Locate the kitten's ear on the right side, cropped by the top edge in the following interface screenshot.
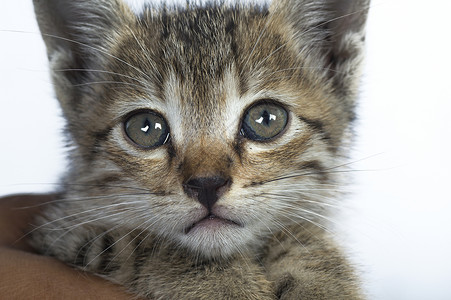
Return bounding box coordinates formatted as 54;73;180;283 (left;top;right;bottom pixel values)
271;0;370;88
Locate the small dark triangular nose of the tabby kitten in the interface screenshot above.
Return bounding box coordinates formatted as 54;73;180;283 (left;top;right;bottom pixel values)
183;176;231;210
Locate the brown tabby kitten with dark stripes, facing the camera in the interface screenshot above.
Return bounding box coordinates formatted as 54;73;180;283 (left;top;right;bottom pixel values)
32;0;369;299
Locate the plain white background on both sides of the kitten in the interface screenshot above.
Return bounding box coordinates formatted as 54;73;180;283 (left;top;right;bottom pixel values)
0;0;451;300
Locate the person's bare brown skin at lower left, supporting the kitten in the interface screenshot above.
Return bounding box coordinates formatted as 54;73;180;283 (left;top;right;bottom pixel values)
0;194;136;300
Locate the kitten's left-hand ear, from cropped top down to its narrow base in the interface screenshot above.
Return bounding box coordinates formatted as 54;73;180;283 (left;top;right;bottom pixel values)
33;0;133;117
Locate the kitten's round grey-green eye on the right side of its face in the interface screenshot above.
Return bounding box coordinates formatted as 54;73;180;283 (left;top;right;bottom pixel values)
241;103;288;141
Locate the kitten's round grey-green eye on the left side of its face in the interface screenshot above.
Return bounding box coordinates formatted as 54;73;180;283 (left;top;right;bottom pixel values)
124;111;169;148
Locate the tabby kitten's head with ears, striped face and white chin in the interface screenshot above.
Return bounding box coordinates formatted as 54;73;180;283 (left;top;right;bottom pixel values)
34;0;369;257
